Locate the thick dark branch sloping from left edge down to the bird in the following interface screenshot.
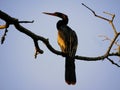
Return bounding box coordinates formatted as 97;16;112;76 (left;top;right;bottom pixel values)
0;11;65;56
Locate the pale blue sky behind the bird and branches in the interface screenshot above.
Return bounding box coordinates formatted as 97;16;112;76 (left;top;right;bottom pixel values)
0;0;120;90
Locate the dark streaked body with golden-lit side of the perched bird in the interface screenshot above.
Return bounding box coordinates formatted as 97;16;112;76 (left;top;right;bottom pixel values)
58;26;78;57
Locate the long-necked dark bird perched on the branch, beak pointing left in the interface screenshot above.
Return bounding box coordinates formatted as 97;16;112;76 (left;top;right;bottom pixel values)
44;12;78;85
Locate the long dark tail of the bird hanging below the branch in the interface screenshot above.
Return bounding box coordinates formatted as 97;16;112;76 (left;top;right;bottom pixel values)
65;57;76;85
